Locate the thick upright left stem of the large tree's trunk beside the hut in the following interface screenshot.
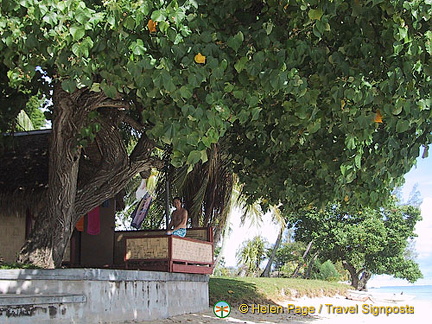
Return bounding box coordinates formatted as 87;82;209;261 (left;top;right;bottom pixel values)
18;86;87;268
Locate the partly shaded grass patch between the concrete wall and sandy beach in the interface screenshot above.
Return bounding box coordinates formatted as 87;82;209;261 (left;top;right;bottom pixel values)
209;277;350;305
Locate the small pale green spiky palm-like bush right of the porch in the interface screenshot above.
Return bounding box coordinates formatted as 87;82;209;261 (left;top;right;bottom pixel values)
236;236;267;276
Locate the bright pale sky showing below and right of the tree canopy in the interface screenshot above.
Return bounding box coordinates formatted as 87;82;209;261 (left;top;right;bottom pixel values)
222;153;432;287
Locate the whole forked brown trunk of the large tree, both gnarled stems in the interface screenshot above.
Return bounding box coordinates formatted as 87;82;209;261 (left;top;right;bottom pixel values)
18;86;160;268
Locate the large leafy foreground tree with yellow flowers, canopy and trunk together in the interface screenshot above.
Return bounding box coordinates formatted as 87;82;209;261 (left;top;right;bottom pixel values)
0;0;432;267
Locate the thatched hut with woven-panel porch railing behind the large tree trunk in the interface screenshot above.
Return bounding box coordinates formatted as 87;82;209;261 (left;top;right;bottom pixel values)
0;130;213;274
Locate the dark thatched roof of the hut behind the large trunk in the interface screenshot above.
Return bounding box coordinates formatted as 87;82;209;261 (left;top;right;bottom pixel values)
0;129;122;215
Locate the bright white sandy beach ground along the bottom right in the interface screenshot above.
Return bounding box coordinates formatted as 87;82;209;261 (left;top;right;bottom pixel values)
135;296;432;324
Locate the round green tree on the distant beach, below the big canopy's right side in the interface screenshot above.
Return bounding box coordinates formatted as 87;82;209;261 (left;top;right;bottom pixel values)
295;204;422;290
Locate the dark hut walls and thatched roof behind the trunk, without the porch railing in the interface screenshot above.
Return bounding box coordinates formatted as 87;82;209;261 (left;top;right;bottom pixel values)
0;130;123;267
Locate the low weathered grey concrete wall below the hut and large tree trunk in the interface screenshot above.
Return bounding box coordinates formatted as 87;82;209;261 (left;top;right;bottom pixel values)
0;269;209;324
